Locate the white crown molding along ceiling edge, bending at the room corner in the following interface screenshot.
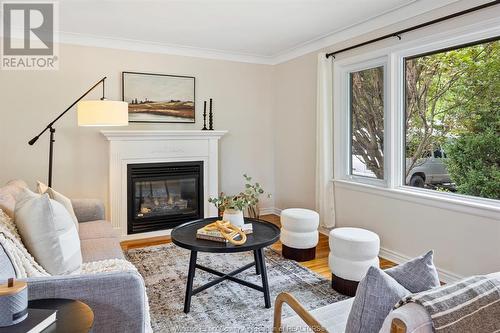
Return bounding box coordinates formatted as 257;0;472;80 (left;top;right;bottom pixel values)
52;0;466;65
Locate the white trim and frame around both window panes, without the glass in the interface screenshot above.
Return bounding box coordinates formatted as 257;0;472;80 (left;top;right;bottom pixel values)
333;18;500;217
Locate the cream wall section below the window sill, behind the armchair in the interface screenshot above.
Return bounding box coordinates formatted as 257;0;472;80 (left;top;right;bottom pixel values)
336;187;500;279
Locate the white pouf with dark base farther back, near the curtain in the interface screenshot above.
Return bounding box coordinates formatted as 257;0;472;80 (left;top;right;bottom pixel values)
280;208;319;261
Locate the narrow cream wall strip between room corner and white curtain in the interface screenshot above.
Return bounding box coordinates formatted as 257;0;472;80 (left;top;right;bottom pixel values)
274;54;317;209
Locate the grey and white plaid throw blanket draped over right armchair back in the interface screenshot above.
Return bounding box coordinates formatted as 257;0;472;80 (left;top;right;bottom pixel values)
396;276;500;333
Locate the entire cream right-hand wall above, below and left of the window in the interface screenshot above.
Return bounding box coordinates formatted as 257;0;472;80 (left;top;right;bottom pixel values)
274;1;500;279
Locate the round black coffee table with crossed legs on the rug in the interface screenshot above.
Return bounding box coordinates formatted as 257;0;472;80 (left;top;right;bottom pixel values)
171;217;280;313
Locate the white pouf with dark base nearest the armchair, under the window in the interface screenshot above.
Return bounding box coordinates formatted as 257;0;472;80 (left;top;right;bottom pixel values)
328;228;380;296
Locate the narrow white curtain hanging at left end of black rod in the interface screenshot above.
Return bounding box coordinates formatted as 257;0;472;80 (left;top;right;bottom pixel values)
316;53;335;228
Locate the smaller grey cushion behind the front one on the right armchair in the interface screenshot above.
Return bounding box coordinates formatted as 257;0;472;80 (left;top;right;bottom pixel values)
385;250;441;293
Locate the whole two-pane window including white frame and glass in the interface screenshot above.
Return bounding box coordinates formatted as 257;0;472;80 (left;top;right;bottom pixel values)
332;24;500;211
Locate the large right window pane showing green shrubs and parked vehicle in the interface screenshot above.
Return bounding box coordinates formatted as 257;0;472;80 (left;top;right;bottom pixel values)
403;40;500;200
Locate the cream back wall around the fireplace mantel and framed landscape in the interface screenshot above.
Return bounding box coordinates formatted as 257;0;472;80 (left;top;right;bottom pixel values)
0;45;274;207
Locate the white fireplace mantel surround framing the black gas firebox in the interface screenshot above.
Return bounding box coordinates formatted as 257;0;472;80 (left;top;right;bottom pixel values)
101;130;227;240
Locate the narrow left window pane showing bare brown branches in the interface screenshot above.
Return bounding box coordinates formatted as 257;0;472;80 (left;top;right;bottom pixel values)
349;66;384;179
